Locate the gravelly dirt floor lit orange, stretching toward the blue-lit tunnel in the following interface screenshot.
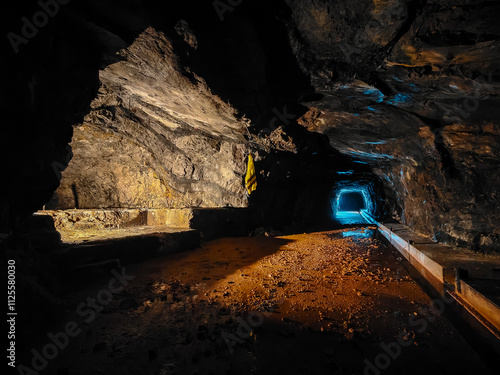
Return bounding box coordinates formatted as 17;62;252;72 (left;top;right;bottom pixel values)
27;227;489;375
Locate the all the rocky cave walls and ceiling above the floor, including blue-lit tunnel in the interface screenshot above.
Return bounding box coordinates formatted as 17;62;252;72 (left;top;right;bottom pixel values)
0;0;500;374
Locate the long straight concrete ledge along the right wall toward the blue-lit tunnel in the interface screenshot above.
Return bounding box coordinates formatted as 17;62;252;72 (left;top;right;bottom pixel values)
368;216;500;353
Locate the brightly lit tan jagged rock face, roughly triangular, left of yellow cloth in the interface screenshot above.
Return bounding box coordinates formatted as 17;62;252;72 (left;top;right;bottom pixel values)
50;28;248;209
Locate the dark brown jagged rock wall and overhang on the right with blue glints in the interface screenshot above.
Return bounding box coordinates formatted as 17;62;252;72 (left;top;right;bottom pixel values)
288;0;500;250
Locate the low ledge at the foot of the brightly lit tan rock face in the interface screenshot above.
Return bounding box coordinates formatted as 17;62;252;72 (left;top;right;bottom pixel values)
34;207;249;279
